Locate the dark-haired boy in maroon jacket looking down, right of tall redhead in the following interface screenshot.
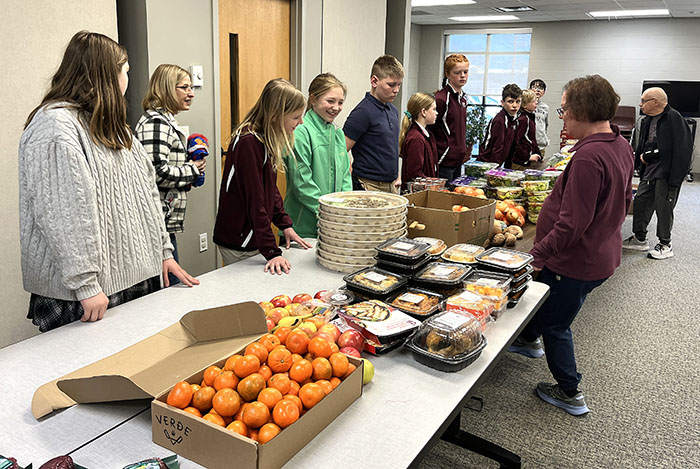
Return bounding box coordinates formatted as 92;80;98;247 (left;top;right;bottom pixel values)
476;83;523;165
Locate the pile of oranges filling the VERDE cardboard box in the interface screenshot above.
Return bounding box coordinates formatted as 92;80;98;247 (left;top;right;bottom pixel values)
166;327;355;444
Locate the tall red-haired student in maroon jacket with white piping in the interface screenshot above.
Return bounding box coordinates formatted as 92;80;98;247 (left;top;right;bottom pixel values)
428;54;469;182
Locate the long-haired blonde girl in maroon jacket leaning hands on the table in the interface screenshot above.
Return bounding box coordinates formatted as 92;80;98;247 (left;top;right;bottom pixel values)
214;78;311;274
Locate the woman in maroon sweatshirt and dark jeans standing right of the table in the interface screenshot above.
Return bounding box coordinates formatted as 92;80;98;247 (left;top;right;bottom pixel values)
509;75;634;415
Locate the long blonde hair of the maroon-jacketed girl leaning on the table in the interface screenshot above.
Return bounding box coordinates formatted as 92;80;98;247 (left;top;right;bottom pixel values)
232;78;306;170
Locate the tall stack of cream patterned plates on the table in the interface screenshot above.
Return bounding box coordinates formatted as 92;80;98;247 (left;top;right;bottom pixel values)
316;191;408;272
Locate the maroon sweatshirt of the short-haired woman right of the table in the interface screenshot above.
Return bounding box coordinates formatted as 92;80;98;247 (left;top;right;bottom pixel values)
530;126;634;281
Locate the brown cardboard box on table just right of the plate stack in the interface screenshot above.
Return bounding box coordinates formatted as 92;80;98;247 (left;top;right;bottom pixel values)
405;191;496;247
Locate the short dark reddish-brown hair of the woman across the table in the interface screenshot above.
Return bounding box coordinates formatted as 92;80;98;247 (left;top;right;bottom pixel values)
564;75;620;122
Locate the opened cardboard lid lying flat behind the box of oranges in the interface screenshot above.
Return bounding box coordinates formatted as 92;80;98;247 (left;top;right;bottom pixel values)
32;301;267;419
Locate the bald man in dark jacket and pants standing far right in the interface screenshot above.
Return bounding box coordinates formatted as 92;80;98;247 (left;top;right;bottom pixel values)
622;88;693;259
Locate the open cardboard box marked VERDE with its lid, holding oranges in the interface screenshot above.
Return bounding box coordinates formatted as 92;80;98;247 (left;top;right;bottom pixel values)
32;302;363;468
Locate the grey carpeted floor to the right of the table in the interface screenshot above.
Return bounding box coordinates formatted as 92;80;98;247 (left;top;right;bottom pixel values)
420;177;700;469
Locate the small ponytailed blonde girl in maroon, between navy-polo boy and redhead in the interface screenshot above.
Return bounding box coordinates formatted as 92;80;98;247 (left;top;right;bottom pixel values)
399;93;438;190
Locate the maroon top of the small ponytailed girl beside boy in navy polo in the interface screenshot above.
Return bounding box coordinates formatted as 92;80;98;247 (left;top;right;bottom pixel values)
401;122;438;189
